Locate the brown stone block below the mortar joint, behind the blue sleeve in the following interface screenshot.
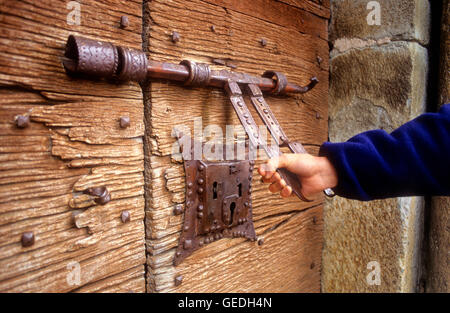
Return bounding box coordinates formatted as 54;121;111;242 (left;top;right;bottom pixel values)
322;42;428;292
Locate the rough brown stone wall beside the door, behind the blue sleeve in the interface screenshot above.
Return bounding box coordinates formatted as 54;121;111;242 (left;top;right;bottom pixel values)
322;0;430;292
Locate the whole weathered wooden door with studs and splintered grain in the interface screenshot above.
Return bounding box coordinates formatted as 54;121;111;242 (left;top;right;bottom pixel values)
0;0;329;292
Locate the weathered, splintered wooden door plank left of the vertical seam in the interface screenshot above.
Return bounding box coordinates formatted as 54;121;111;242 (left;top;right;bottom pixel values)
0;0;145;292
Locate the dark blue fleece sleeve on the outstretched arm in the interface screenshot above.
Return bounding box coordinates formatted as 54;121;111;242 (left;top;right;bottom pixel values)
319;104;450;201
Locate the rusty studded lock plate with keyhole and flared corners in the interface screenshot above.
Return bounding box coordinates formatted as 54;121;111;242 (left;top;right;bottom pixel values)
173;136;256;265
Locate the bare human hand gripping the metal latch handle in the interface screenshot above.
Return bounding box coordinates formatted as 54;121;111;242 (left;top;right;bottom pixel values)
258;153;338;198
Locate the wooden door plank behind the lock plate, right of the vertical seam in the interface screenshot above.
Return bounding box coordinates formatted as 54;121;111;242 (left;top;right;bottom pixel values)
144;0;328;292
